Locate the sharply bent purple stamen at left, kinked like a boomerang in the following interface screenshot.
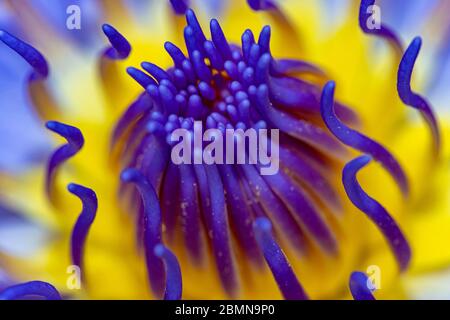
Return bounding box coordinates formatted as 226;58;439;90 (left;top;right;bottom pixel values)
46;121;84;199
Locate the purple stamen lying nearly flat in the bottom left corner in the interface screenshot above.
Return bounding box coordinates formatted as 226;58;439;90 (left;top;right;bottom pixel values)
0;281;61;300
